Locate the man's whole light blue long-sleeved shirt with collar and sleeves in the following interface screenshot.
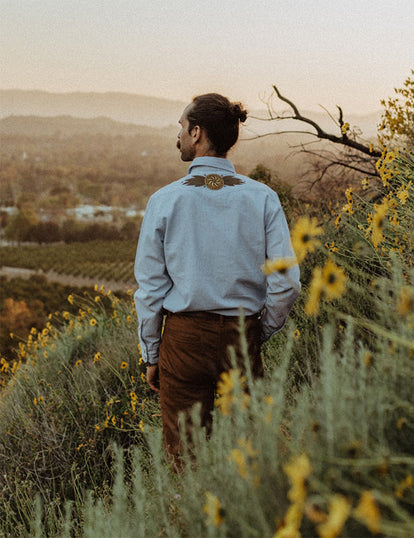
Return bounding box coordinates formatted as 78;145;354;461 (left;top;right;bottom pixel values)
135;157;300;364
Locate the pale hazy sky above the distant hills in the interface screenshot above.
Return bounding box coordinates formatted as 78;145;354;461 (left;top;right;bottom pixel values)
0;0;414;112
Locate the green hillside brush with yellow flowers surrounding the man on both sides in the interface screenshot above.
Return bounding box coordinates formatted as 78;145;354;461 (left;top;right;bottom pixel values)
0;77;414;538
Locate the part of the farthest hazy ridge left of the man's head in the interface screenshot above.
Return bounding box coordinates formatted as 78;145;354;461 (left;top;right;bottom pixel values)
0;90;186;127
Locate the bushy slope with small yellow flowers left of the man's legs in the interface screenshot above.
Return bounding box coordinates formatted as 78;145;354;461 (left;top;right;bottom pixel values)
0;289;158;536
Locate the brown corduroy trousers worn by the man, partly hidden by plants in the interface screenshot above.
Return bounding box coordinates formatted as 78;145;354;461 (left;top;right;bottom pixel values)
159;312;263;462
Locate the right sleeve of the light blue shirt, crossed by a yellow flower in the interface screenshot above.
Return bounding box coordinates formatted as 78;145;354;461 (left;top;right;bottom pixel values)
262;192;301;342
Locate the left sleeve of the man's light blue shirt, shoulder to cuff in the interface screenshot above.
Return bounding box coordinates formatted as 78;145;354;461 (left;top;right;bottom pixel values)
134;198;172;364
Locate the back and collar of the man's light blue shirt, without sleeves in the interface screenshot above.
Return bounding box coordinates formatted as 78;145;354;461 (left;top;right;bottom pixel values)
144;157;276;315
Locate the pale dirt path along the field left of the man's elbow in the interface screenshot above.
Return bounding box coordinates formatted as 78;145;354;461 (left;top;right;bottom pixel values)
0;266;137;291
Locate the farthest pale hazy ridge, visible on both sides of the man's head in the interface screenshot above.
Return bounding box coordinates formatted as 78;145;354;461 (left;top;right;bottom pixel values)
0;90;380;137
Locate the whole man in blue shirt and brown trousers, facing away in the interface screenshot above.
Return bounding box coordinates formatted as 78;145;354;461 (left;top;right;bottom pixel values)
135;93;300;459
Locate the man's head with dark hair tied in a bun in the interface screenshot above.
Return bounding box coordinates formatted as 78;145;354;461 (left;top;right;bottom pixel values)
177;93;247;161
